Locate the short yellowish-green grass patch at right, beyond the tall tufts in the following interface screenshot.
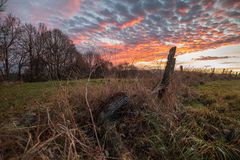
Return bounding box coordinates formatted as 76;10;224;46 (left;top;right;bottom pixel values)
192;80;240;120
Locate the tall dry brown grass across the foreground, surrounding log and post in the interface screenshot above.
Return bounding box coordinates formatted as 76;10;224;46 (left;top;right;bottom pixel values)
0;73;240;160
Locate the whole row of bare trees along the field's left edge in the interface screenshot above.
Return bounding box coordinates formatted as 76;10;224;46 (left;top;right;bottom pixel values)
0;15;112;81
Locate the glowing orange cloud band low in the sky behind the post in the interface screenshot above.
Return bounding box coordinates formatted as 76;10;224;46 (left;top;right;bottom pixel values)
102;31;240;64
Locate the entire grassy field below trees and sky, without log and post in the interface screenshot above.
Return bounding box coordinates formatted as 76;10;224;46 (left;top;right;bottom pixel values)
0;79;240;160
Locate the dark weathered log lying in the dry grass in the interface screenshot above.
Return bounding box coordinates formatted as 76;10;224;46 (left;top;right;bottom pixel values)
96;92;129;123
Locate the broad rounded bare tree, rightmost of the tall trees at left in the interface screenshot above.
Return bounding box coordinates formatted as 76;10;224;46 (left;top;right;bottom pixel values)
44;29;77;79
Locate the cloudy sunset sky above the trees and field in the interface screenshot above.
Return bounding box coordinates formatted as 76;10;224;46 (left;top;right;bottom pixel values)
1;0;240;71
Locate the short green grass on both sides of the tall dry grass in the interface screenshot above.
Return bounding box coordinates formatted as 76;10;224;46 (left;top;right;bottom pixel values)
0;79;240;113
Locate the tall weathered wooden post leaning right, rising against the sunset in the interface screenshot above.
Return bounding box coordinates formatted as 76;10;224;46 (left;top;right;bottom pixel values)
154;47;176;99
